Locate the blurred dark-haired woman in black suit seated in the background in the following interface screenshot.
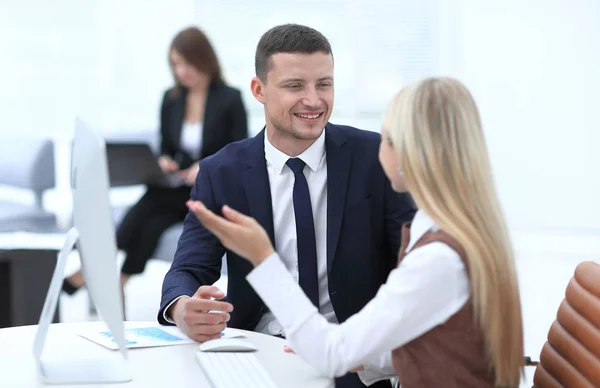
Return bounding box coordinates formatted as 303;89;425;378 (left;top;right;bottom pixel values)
63;27;248;294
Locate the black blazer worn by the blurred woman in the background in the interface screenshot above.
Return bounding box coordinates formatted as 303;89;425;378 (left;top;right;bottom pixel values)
160;83;248;169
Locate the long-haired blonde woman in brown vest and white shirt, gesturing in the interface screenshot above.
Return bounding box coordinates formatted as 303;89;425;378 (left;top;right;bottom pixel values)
188;78;523;388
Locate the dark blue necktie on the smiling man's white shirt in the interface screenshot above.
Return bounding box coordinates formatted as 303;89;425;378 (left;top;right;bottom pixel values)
286;158;319;308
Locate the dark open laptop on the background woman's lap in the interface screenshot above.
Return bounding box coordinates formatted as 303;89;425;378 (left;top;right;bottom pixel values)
106;142;186;188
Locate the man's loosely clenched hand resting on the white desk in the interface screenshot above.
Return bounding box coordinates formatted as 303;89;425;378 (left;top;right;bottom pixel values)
170;286;233;342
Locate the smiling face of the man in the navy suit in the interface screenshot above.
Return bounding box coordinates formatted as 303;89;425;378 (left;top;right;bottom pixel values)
252;52;333;141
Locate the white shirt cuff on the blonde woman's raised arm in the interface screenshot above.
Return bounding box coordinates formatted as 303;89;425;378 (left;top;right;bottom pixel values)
246;252;317;333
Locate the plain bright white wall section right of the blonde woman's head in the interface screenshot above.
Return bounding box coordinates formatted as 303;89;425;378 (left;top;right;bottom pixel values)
454;0;600;238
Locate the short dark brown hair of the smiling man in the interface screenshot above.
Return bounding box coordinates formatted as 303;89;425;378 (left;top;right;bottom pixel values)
254;24;331;83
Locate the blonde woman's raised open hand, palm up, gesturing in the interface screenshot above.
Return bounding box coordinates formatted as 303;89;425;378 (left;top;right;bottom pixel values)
186;201;274;266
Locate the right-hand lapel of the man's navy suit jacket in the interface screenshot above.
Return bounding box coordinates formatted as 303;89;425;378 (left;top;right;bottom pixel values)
325;124;352;274
